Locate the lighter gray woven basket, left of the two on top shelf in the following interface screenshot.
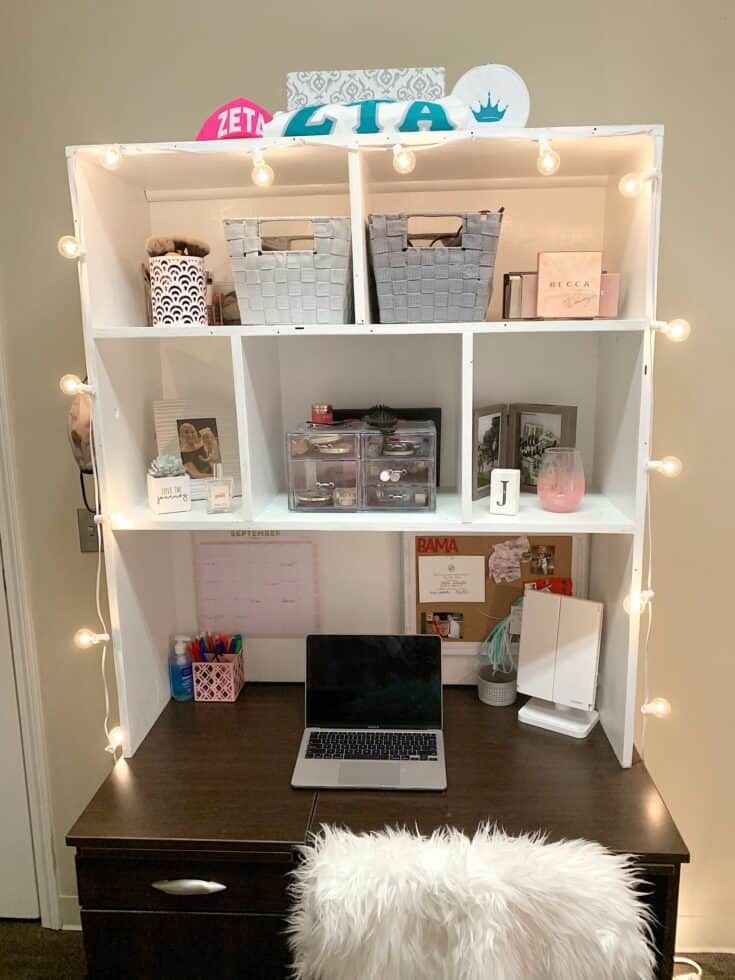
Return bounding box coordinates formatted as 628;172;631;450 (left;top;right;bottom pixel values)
224;217;352;325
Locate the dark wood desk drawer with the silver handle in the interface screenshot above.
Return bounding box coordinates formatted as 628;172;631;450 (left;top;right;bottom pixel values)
77;851;294;915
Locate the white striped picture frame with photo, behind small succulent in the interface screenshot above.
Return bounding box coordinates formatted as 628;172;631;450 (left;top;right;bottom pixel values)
153;398;242;500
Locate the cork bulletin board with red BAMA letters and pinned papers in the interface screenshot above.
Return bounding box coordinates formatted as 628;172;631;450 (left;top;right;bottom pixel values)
404;534;586;652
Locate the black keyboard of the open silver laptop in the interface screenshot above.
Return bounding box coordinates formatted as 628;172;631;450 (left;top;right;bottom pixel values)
306;732;437;762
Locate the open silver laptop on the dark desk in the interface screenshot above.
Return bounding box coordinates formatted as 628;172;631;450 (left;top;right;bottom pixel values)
291;634;447;790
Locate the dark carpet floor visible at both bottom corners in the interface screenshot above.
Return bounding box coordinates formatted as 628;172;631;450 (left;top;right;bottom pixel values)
0;919;735;980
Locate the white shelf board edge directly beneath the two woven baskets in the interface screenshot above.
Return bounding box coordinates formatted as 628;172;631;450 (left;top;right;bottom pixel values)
91;319;650;342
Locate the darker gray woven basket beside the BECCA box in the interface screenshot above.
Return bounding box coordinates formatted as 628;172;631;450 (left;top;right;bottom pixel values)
368;210;503;323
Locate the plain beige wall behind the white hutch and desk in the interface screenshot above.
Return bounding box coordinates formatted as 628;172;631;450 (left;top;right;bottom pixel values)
0;0;735;948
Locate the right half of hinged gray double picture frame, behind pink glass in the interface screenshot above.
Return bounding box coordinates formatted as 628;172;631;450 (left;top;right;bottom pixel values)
509;404;577;493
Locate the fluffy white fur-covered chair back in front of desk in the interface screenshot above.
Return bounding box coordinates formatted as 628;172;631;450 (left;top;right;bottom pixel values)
289;827;654;980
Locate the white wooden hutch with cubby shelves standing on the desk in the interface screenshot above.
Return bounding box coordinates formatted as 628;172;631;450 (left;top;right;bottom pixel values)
67;126;663;766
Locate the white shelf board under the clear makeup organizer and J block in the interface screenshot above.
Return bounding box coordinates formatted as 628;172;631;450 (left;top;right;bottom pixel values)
113;491;636;534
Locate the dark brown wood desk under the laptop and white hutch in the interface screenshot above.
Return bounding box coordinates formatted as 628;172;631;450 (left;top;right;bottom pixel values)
67;684;689;980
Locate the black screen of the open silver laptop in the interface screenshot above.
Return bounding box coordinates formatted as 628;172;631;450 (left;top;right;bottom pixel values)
306;634;442;729
